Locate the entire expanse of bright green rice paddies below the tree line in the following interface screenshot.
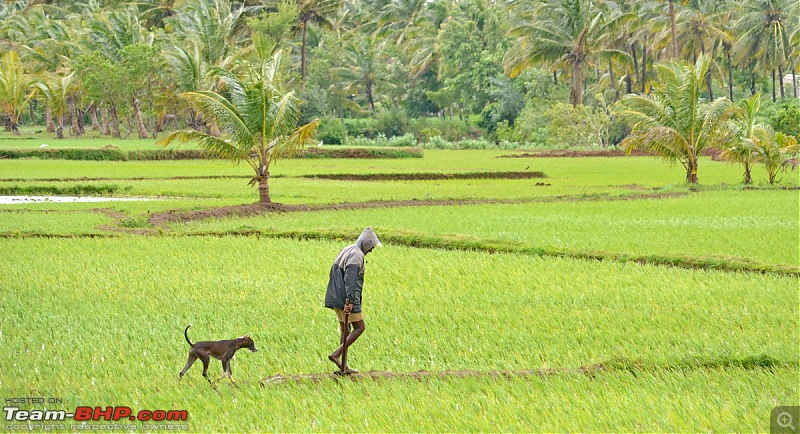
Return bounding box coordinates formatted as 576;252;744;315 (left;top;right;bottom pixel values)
0;137;800;432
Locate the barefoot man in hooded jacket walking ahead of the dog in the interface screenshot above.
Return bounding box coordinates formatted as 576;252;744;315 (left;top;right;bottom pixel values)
325;228;381;374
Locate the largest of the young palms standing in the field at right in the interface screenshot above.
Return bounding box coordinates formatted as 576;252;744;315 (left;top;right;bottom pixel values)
617;55;732;184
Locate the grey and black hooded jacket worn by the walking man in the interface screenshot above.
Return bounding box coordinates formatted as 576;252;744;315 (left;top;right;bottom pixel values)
325;228;381;313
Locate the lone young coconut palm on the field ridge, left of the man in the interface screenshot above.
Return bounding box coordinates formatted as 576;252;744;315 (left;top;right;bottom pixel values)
157;51;317;205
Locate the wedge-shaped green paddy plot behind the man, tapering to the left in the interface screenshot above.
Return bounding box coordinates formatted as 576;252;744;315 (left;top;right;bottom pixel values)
171;191;800;267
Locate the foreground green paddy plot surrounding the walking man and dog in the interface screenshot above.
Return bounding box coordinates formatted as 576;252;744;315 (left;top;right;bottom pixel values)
0;237;799;431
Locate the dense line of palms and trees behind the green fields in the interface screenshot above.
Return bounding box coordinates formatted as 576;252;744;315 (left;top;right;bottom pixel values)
0;0;800;145
